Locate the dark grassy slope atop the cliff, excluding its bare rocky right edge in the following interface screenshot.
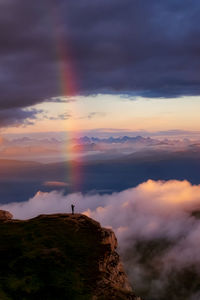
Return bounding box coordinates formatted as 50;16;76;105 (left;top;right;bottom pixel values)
0;215;108;300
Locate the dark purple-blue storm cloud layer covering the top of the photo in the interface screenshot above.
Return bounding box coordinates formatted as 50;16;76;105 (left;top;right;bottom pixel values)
0;0;200;122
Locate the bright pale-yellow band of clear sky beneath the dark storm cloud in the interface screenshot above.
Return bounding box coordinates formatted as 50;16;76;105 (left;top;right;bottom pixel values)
3;94;200;134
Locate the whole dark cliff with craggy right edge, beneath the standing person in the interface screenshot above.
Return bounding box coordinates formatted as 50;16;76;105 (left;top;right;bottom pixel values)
0;213;140;300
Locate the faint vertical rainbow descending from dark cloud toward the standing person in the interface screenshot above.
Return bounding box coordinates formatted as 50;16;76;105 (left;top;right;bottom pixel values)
48;1;81;191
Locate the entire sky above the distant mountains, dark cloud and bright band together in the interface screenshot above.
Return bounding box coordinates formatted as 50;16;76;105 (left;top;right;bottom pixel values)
0;0;200;134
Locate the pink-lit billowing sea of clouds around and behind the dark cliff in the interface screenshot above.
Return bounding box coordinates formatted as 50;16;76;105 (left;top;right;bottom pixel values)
0;180;200;300
